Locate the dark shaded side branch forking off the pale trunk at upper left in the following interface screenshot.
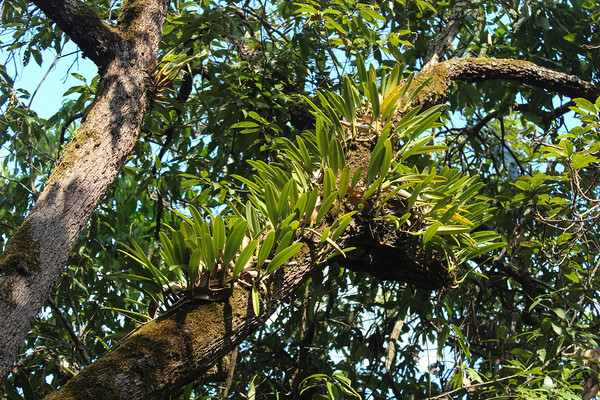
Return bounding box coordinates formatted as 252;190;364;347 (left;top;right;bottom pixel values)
32;0;121;69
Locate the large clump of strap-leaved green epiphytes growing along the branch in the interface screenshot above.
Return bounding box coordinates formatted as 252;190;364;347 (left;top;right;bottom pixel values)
112;57;503;315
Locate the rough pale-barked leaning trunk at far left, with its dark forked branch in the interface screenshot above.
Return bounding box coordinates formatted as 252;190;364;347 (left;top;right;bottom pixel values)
0;0;168;387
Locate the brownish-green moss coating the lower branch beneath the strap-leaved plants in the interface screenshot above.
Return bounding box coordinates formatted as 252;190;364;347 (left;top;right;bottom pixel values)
46;289;249;400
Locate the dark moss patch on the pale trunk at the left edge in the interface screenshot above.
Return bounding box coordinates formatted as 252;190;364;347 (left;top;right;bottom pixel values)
0;222;40;276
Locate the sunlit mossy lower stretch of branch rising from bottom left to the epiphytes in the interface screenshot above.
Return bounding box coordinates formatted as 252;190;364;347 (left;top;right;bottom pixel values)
47;248;316;400
